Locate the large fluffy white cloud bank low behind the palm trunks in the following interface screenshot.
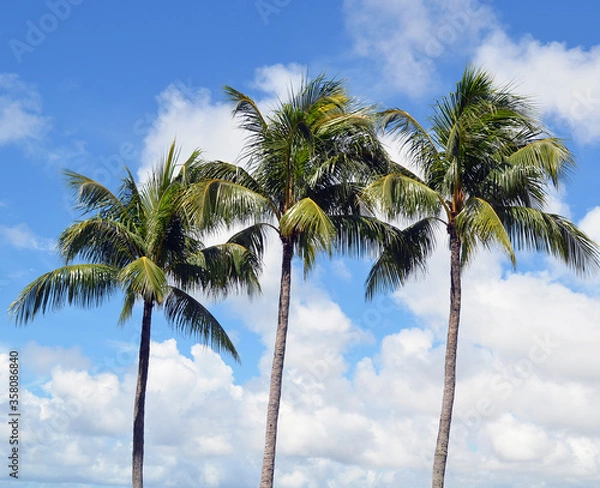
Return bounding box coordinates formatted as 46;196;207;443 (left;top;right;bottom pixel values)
7;241;600;488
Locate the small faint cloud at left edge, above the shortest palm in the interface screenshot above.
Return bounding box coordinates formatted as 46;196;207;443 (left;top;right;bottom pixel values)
0;73;49;146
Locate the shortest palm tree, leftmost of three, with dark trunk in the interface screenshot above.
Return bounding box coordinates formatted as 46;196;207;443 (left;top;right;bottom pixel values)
9;144;262;488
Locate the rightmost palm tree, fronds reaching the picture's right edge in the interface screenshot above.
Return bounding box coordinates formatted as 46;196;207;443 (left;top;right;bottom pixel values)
365;67;599;488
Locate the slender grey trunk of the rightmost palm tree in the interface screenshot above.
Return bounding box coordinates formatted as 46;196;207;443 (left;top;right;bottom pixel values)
432;223;461;488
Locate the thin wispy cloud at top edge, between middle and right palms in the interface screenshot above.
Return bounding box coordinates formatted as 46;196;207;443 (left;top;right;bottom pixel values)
344;0;496;96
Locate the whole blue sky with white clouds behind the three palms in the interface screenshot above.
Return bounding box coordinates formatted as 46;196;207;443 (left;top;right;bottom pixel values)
0;0;600;488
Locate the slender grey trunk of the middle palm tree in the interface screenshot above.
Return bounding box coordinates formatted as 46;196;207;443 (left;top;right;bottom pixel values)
260;238;294;488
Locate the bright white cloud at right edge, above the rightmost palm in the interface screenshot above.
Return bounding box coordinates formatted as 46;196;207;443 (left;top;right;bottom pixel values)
476;31;600;143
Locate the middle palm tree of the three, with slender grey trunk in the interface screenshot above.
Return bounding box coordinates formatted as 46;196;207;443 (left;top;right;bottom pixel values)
190;76;412;488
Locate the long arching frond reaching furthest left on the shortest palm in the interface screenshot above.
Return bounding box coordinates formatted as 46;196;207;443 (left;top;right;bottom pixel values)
8;264;119;324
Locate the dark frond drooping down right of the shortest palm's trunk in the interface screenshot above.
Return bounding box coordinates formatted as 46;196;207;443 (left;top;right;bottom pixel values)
163;287;240;362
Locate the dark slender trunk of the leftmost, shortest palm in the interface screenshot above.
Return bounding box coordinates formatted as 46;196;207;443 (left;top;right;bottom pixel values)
131;301;154;488
